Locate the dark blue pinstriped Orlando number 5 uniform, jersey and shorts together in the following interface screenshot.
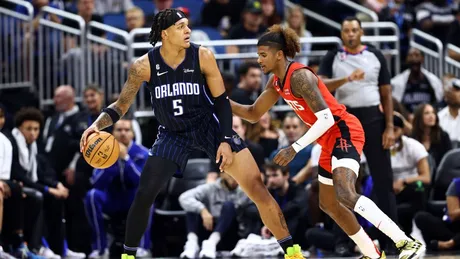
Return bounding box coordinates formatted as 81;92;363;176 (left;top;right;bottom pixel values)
148;44;246;177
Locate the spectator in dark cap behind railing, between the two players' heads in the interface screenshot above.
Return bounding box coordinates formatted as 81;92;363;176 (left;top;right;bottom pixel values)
227;0;266;53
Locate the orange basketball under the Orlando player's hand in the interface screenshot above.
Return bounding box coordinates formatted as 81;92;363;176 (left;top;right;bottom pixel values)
83;131;120;169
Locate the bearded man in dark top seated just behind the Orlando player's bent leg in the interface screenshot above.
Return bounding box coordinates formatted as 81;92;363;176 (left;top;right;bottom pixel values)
261;165;307;244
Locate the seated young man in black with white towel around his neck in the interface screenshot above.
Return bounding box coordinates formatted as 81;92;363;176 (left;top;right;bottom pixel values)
10;108;86;258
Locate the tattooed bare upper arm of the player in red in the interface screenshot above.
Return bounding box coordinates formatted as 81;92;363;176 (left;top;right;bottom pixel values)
291;69;328;113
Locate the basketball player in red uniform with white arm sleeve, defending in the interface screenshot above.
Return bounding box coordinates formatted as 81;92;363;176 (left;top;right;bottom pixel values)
230;25;425;259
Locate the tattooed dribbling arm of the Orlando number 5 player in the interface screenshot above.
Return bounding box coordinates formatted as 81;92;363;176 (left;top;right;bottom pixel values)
95;59;150;130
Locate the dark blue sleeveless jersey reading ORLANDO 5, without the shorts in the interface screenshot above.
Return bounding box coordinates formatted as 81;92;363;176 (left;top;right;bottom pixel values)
147;43;214;132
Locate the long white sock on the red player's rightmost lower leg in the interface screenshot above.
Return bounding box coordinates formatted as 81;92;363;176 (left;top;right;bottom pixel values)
354;195;410;243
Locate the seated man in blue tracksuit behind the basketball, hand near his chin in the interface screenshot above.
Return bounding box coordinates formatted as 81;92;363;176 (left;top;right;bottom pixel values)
85;119;150;259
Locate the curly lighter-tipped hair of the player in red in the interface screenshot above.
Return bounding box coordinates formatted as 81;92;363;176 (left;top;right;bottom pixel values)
257;24;300;58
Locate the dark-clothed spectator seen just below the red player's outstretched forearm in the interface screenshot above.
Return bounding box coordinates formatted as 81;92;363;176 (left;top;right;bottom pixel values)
246;112;282;159
